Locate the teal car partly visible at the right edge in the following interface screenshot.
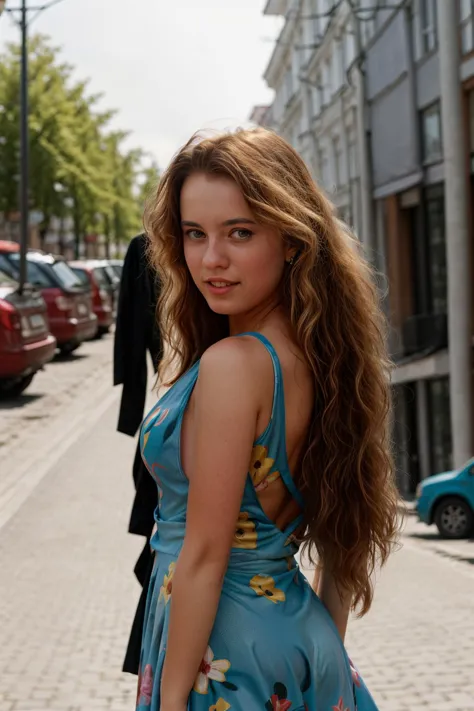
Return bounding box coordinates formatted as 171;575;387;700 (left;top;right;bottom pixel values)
416;458;474;538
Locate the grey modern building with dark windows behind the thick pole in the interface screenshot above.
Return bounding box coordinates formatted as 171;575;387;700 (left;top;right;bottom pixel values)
366;0;474;494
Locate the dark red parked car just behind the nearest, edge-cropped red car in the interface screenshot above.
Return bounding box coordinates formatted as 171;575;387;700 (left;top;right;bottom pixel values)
0;242;97;355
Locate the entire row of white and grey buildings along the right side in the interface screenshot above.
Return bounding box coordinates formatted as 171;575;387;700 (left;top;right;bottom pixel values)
258;0;474;495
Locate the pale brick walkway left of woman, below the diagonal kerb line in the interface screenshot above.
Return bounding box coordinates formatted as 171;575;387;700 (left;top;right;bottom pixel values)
0;390;143;711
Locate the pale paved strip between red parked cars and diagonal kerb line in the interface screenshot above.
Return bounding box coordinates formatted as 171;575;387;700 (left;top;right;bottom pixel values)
0;335;116;528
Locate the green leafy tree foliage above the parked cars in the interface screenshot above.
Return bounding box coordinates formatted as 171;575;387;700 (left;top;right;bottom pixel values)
0;35;158;254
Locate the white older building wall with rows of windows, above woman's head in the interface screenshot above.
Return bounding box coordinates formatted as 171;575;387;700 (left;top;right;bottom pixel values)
265;0;372;232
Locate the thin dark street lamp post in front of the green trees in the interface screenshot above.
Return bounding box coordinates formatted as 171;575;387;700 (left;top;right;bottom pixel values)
0;0;67;292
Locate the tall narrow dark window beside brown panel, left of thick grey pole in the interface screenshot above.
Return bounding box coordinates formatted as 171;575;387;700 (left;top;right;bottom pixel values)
426;186;448;314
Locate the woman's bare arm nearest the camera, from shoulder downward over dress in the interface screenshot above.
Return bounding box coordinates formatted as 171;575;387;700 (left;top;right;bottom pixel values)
160;339;259;711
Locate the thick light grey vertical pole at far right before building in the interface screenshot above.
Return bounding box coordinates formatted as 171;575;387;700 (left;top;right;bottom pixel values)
437;0;474;467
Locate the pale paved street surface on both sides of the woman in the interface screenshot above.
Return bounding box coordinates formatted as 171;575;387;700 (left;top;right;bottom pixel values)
0;337;474;711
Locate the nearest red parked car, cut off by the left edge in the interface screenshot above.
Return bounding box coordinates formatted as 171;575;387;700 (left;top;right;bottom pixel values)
0;269;56;397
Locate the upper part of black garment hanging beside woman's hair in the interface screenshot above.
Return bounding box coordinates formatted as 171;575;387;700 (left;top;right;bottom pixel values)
114;234;161;437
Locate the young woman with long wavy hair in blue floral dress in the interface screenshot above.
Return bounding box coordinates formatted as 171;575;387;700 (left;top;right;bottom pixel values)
137;129;397;711
